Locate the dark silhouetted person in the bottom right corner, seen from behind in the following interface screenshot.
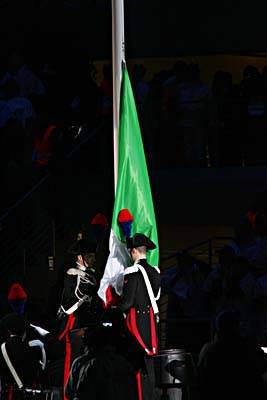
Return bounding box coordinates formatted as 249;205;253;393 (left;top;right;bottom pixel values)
198;310;267;400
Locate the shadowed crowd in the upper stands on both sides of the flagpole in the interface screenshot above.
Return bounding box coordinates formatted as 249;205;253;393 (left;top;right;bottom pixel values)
0;50;267;188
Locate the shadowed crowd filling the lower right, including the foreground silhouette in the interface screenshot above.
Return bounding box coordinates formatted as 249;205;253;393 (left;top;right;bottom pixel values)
162;193;267;399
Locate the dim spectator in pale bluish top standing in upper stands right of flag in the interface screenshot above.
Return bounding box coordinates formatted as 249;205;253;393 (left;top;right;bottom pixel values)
163;62;210;166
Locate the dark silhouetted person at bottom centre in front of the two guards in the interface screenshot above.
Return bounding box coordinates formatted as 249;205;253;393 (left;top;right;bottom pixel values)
73;325;138;400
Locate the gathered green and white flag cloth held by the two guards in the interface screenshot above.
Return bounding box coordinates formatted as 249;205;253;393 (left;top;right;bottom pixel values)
98;67;159;302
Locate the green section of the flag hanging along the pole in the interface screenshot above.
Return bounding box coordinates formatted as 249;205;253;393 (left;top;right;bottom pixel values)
112;68;159;265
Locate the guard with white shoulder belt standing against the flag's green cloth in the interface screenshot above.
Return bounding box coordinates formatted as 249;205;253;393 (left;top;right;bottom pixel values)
118;233;160;400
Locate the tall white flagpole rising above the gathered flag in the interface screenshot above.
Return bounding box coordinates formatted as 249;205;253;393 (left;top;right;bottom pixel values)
111;0;125;193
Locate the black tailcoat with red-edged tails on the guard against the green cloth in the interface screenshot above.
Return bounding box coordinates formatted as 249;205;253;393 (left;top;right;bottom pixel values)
118;259;160;354
